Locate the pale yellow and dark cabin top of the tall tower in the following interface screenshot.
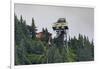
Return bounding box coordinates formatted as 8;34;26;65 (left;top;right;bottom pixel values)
52;18;68;30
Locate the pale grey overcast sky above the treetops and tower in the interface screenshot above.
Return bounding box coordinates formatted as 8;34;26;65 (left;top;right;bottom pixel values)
14;4;94;40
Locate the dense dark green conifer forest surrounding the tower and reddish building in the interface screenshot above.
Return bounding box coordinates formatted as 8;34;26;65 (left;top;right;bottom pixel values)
14;15;94;65
